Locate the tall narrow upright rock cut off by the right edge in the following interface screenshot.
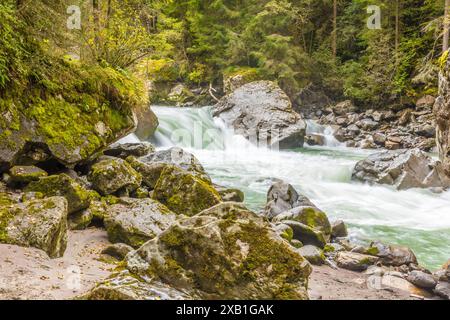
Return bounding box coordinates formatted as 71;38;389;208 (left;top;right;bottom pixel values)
434;52;450;176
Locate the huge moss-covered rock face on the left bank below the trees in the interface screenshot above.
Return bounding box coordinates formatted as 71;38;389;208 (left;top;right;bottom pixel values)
0;50;151;170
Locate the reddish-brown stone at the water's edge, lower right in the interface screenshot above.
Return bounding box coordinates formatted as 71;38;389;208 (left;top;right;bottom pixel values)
368;241;417;267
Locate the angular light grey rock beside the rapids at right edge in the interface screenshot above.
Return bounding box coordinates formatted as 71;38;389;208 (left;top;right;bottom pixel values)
352;149;450;190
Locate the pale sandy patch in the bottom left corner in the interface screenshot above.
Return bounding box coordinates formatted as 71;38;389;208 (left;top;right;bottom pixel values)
0;228;115;300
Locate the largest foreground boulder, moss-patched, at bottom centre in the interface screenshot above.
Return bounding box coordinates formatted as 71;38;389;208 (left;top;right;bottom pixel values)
126;203;311;299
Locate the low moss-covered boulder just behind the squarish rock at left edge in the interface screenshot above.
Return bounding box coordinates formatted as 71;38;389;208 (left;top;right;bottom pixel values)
25;173;91;214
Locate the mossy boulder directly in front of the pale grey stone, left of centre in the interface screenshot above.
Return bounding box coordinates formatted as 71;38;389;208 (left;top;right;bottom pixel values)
152;166;221;216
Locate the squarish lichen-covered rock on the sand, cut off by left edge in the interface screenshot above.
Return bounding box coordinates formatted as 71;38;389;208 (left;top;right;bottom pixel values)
0;197;67;258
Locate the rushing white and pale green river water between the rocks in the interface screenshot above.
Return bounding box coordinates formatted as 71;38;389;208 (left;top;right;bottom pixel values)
135;107;450;269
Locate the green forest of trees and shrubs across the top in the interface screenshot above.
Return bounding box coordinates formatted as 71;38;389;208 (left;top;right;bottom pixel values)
0;0;449;107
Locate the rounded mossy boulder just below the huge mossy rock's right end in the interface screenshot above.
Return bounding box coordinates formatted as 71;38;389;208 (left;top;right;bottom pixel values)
88;158;142;195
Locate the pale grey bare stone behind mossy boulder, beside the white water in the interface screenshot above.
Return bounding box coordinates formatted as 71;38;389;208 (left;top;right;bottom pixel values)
138;147;211;182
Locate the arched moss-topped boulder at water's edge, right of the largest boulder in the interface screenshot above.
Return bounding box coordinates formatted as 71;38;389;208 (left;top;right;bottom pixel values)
273;206;331;242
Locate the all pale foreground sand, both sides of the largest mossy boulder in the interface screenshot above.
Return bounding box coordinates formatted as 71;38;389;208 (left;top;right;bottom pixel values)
0;228;436;300
